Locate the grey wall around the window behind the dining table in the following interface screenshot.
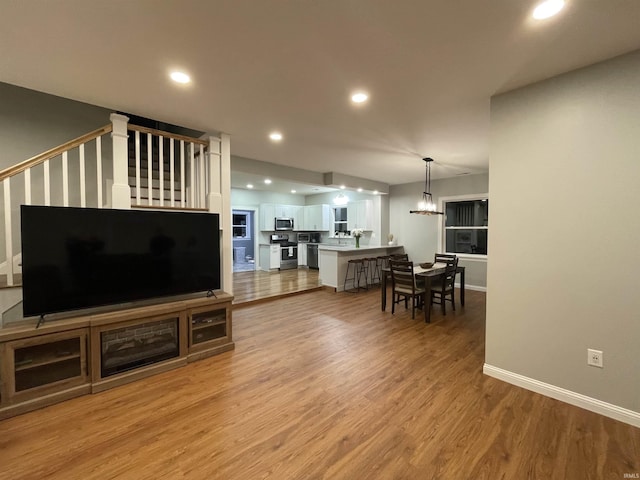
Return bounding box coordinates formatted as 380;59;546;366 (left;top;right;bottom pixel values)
389;174;492;289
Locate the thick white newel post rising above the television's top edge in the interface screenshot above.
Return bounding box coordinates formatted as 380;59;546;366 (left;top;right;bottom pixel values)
109;113;131;210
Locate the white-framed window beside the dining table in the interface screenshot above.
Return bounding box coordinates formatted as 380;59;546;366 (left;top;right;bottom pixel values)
443;198;489;255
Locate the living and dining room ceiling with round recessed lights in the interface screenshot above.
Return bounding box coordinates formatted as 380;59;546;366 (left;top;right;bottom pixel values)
0;0;640;192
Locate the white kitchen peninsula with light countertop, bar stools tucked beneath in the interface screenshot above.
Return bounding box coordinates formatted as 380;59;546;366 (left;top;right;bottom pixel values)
318;244;404;292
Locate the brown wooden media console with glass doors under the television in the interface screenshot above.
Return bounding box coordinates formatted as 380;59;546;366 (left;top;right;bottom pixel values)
0;293;234;420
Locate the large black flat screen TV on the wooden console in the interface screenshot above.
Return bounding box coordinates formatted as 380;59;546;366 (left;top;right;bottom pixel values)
21;205;220;317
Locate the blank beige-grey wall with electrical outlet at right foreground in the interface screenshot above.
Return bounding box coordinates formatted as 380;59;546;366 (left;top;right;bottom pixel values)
485;51;640;425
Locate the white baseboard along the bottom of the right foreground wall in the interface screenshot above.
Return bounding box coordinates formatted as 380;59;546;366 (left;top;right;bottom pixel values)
482;363;640;428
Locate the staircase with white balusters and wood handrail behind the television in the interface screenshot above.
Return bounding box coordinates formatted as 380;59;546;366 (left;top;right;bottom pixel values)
0;114;231;287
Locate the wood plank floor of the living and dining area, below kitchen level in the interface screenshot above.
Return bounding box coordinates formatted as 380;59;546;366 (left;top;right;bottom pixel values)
0;289;640;480
